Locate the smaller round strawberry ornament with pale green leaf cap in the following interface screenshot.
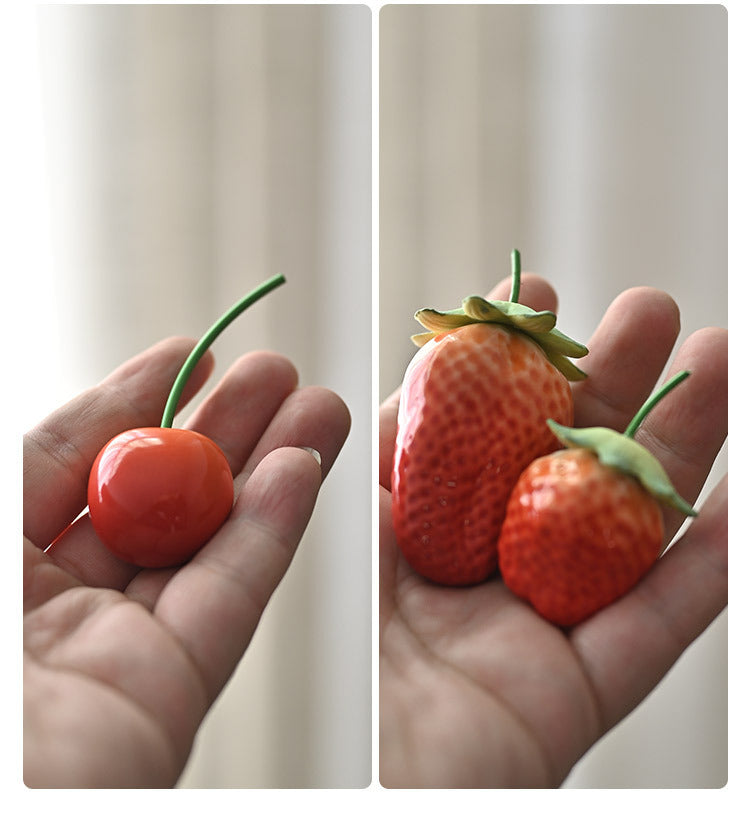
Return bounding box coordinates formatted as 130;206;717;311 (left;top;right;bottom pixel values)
498;372;696;627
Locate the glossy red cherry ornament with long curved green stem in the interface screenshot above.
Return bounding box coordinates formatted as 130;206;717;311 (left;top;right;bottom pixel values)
88;275;284;568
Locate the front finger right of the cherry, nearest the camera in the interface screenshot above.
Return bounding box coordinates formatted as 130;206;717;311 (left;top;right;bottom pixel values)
154;448;321;699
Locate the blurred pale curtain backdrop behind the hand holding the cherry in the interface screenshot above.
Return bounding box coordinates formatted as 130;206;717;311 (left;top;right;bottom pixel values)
31;5;372;788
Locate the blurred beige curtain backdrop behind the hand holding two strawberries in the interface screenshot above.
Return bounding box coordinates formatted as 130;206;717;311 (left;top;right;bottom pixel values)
379;4;727;788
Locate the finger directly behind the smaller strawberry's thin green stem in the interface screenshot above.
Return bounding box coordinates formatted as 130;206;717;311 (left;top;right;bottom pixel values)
635;327;728;541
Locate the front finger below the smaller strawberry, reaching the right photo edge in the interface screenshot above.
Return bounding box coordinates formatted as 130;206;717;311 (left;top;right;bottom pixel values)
571;477;727;731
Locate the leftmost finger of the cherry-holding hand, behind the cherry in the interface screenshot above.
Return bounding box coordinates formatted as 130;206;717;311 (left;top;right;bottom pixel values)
23;338;213;549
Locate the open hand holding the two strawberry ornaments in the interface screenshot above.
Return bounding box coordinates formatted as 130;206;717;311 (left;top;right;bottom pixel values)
380;275;727;788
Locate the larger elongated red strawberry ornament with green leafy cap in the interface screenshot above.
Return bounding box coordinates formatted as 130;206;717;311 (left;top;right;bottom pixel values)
392;251;587;585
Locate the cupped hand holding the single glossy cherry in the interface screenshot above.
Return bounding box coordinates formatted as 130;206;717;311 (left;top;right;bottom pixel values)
24;338;349;788
